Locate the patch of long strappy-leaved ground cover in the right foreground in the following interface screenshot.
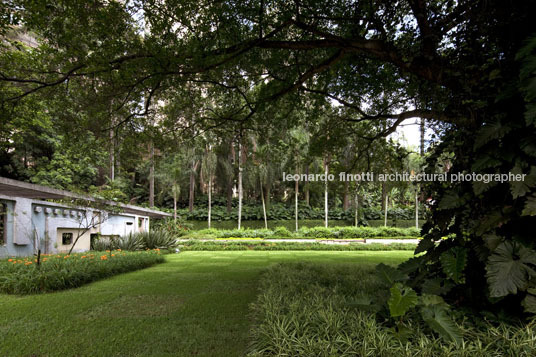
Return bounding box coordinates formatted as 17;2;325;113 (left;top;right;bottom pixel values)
250;263;536;356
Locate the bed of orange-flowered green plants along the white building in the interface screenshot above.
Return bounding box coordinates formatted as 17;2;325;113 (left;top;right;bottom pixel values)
0;249;164;294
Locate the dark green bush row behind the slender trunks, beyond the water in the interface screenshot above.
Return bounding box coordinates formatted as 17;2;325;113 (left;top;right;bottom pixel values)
179;203;424;224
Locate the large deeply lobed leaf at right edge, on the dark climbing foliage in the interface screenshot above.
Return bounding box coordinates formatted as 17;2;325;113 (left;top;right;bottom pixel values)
486;241;536;297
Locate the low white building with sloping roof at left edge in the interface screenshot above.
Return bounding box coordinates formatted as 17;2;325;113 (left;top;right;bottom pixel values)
0;177;171;258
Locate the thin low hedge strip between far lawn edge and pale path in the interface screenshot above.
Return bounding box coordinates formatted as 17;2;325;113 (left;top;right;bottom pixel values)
180;240;417;251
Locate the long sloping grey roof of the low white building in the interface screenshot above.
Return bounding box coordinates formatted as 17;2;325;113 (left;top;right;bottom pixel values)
0;177;171;218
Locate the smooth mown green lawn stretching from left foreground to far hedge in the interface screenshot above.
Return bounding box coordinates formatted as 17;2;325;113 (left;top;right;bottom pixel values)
0;251;413;356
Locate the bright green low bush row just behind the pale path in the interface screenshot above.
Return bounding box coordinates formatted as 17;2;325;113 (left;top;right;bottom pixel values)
185;226;420;239
